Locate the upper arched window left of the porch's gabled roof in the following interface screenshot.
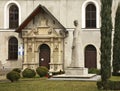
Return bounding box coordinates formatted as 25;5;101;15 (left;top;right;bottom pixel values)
9;5;19;29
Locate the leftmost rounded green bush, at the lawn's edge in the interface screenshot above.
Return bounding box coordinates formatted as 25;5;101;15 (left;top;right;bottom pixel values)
6;71;20;82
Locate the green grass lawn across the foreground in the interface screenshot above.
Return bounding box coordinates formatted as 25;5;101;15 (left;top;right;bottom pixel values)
0;77;120;91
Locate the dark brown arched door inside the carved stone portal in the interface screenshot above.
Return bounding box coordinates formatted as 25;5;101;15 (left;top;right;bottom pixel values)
39;44;50;69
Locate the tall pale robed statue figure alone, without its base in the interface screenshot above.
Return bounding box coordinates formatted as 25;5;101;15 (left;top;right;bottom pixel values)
70;20;80;67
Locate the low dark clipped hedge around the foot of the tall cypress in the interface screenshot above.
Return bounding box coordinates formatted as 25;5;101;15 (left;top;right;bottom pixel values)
97;81;120;90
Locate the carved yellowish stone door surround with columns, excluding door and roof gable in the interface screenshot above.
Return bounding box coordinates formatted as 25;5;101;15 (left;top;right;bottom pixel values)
23;27;63;71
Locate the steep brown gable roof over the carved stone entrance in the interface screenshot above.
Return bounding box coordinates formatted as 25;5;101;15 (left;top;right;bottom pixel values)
15;5;66;33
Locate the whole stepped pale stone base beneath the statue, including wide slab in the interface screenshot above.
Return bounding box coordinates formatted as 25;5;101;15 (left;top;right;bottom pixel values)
50;67;100;81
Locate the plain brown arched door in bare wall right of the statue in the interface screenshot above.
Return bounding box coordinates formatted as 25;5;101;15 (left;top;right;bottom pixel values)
85;45;97;68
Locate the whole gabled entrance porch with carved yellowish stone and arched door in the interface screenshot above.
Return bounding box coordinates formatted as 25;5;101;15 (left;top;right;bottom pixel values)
19;6;66;72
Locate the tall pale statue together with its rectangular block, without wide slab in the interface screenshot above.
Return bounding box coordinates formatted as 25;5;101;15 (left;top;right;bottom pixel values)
65;20;88;75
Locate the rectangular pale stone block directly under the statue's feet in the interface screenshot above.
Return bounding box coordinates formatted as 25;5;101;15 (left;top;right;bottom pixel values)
65;67;88;75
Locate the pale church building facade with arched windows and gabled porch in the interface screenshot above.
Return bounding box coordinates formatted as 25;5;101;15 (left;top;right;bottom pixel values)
0;0;120;71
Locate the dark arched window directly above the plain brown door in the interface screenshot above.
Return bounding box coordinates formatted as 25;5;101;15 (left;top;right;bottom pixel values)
86;4;96;28
